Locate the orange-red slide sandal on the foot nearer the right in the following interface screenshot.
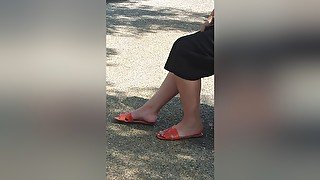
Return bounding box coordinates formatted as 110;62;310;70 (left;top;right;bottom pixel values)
156;127;203;141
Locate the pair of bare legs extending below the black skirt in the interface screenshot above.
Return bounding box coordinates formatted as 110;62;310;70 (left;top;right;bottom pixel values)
131;72;203;136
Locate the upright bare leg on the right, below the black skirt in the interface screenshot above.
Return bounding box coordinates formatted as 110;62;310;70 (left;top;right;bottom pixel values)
170;76;203;136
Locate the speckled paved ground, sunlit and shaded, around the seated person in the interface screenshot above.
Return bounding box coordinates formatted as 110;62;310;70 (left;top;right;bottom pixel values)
106;0;213;179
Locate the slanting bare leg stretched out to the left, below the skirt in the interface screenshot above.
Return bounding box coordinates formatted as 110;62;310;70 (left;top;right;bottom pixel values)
131;72;178;122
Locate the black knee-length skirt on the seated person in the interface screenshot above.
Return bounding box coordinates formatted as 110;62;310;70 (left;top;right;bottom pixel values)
164;26;214;80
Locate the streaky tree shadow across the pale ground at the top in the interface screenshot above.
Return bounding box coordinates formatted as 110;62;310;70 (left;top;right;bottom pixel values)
106;2;207;36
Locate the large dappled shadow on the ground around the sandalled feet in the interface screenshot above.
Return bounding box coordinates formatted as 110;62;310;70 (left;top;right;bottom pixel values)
106;88;214;179
